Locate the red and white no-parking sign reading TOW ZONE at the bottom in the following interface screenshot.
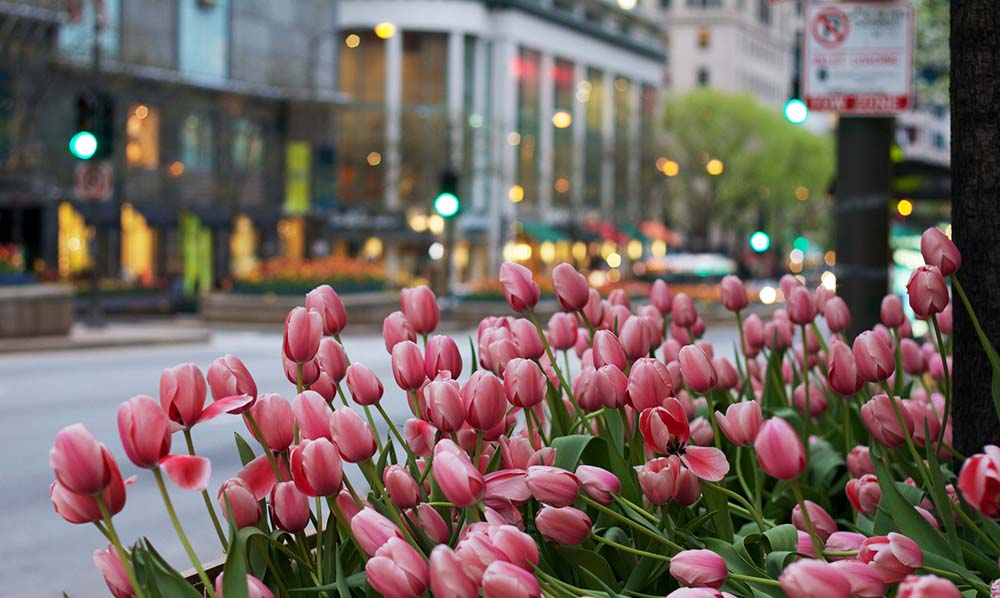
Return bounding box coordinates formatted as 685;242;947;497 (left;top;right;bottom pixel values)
802;0;913;115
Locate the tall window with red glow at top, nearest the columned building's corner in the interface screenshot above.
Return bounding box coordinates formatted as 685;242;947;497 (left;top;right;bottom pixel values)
513;48;542;202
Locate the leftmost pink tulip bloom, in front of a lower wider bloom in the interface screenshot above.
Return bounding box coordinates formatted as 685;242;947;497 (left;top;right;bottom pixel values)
49;424;112;496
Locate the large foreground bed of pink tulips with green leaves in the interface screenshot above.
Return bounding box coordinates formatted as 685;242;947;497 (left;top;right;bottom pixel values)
50;229;1000;598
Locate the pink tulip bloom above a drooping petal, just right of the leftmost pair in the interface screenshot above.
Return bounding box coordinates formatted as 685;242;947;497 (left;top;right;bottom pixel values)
118;395;171;469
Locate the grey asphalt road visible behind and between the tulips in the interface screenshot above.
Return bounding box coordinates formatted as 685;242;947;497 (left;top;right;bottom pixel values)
0;328;735;598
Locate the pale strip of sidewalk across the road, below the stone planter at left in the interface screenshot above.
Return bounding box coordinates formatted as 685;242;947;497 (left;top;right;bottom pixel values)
0;318;211;354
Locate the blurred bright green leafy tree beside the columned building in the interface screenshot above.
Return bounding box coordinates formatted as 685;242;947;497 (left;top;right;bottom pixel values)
665;89;834;250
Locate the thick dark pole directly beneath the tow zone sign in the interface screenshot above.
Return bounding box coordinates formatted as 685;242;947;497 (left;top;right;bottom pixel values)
835;116;895;338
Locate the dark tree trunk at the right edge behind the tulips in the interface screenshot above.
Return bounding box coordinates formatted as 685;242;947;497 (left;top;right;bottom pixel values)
951;0;1000;454
